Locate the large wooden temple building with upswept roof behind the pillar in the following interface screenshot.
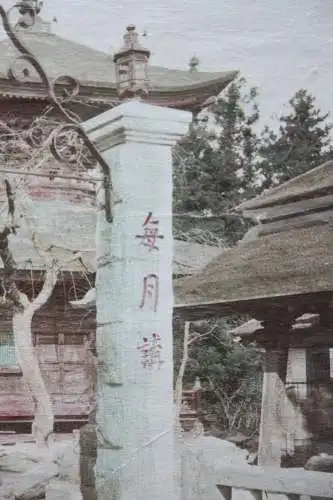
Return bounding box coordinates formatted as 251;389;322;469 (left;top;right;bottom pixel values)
0;5;237;432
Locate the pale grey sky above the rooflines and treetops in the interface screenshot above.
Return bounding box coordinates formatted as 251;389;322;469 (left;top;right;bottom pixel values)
3;0;333;125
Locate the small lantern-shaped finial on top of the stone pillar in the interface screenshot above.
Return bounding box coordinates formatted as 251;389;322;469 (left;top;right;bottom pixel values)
113;24;150;98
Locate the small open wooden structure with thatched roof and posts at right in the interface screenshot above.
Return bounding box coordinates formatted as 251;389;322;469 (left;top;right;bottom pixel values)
175;162;333;466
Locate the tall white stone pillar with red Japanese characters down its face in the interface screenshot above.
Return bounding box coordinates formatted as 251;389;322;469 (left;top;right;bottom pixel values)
84;101;191;500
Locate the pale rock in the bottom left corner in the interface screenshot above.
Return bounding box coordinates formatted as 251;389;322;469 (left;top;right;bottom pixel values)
0;463;58;500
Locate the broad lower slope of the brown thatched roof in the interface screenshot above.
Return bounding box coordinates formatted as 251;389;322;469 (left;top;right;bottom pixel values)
175;224;333;307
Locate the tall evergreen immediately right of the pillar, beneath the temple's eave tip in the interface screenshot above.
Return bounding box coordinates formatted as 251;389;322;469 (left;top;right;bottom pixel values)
174;79;259;243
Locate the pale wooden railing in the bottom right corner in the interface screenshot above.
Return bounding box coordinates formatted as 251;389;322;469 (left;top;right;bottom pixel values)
217;466;333;500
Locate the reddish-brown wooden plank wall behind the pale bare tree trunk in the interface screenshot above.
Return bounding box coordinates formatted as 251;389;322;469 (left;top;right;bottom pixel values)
0;283;95;421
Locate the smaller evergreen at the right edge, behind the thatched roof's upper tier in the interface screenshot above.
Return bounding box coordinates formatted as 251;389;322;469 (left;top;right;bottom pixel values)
257;89;332;189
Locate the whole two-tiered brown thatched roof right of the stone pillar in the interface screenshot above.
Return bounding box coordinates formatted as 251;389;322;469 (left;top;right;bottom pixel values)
175;161;333;317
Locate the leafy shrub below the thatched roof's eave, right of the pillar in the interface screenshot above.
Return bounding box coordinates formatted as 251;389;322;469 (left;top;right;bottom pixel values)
174;319;263;435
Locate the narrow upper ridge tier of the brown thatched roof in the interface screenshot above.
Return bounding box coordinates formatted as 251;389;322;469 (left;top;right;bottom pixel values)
237;161;333;212
